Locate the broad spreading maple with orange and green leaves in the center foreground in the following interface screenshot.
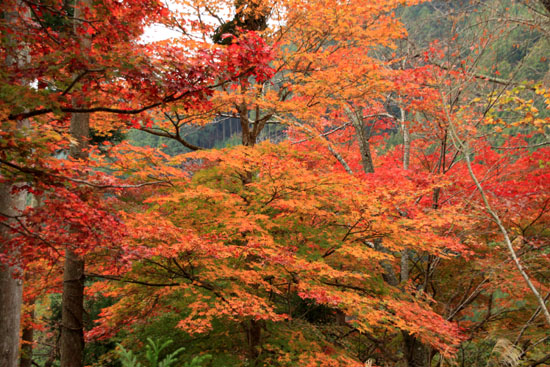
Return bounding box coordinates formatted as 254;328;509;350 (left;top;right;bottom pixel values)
83;144;466;364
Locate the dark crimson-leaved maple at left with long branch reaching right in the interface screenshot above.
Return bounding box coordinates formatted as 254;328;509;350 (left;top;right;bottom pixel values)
0;1;276;366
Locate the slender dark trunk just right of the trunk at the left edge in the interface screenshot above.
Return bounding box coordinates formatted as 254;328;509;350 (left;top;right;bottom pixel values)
60;0;92;367
